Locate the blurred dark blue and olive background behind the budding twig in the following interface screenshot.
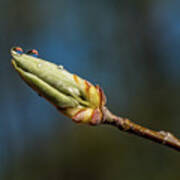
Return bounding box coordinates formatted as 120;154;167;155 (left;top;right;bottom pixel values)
0;0;180;180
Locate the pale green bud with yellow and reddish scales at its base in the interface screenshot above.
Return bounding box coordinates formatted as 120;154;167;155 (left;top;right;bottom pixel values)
11;47;106;125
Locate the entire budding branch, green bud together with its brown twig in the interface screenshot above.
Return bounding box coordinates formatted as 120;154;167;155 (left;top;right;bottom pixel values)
11;47;180;151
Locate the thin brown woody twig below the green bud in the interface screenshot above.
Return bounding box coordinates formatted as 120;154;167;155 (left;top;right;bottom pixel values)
102;107;180;151
